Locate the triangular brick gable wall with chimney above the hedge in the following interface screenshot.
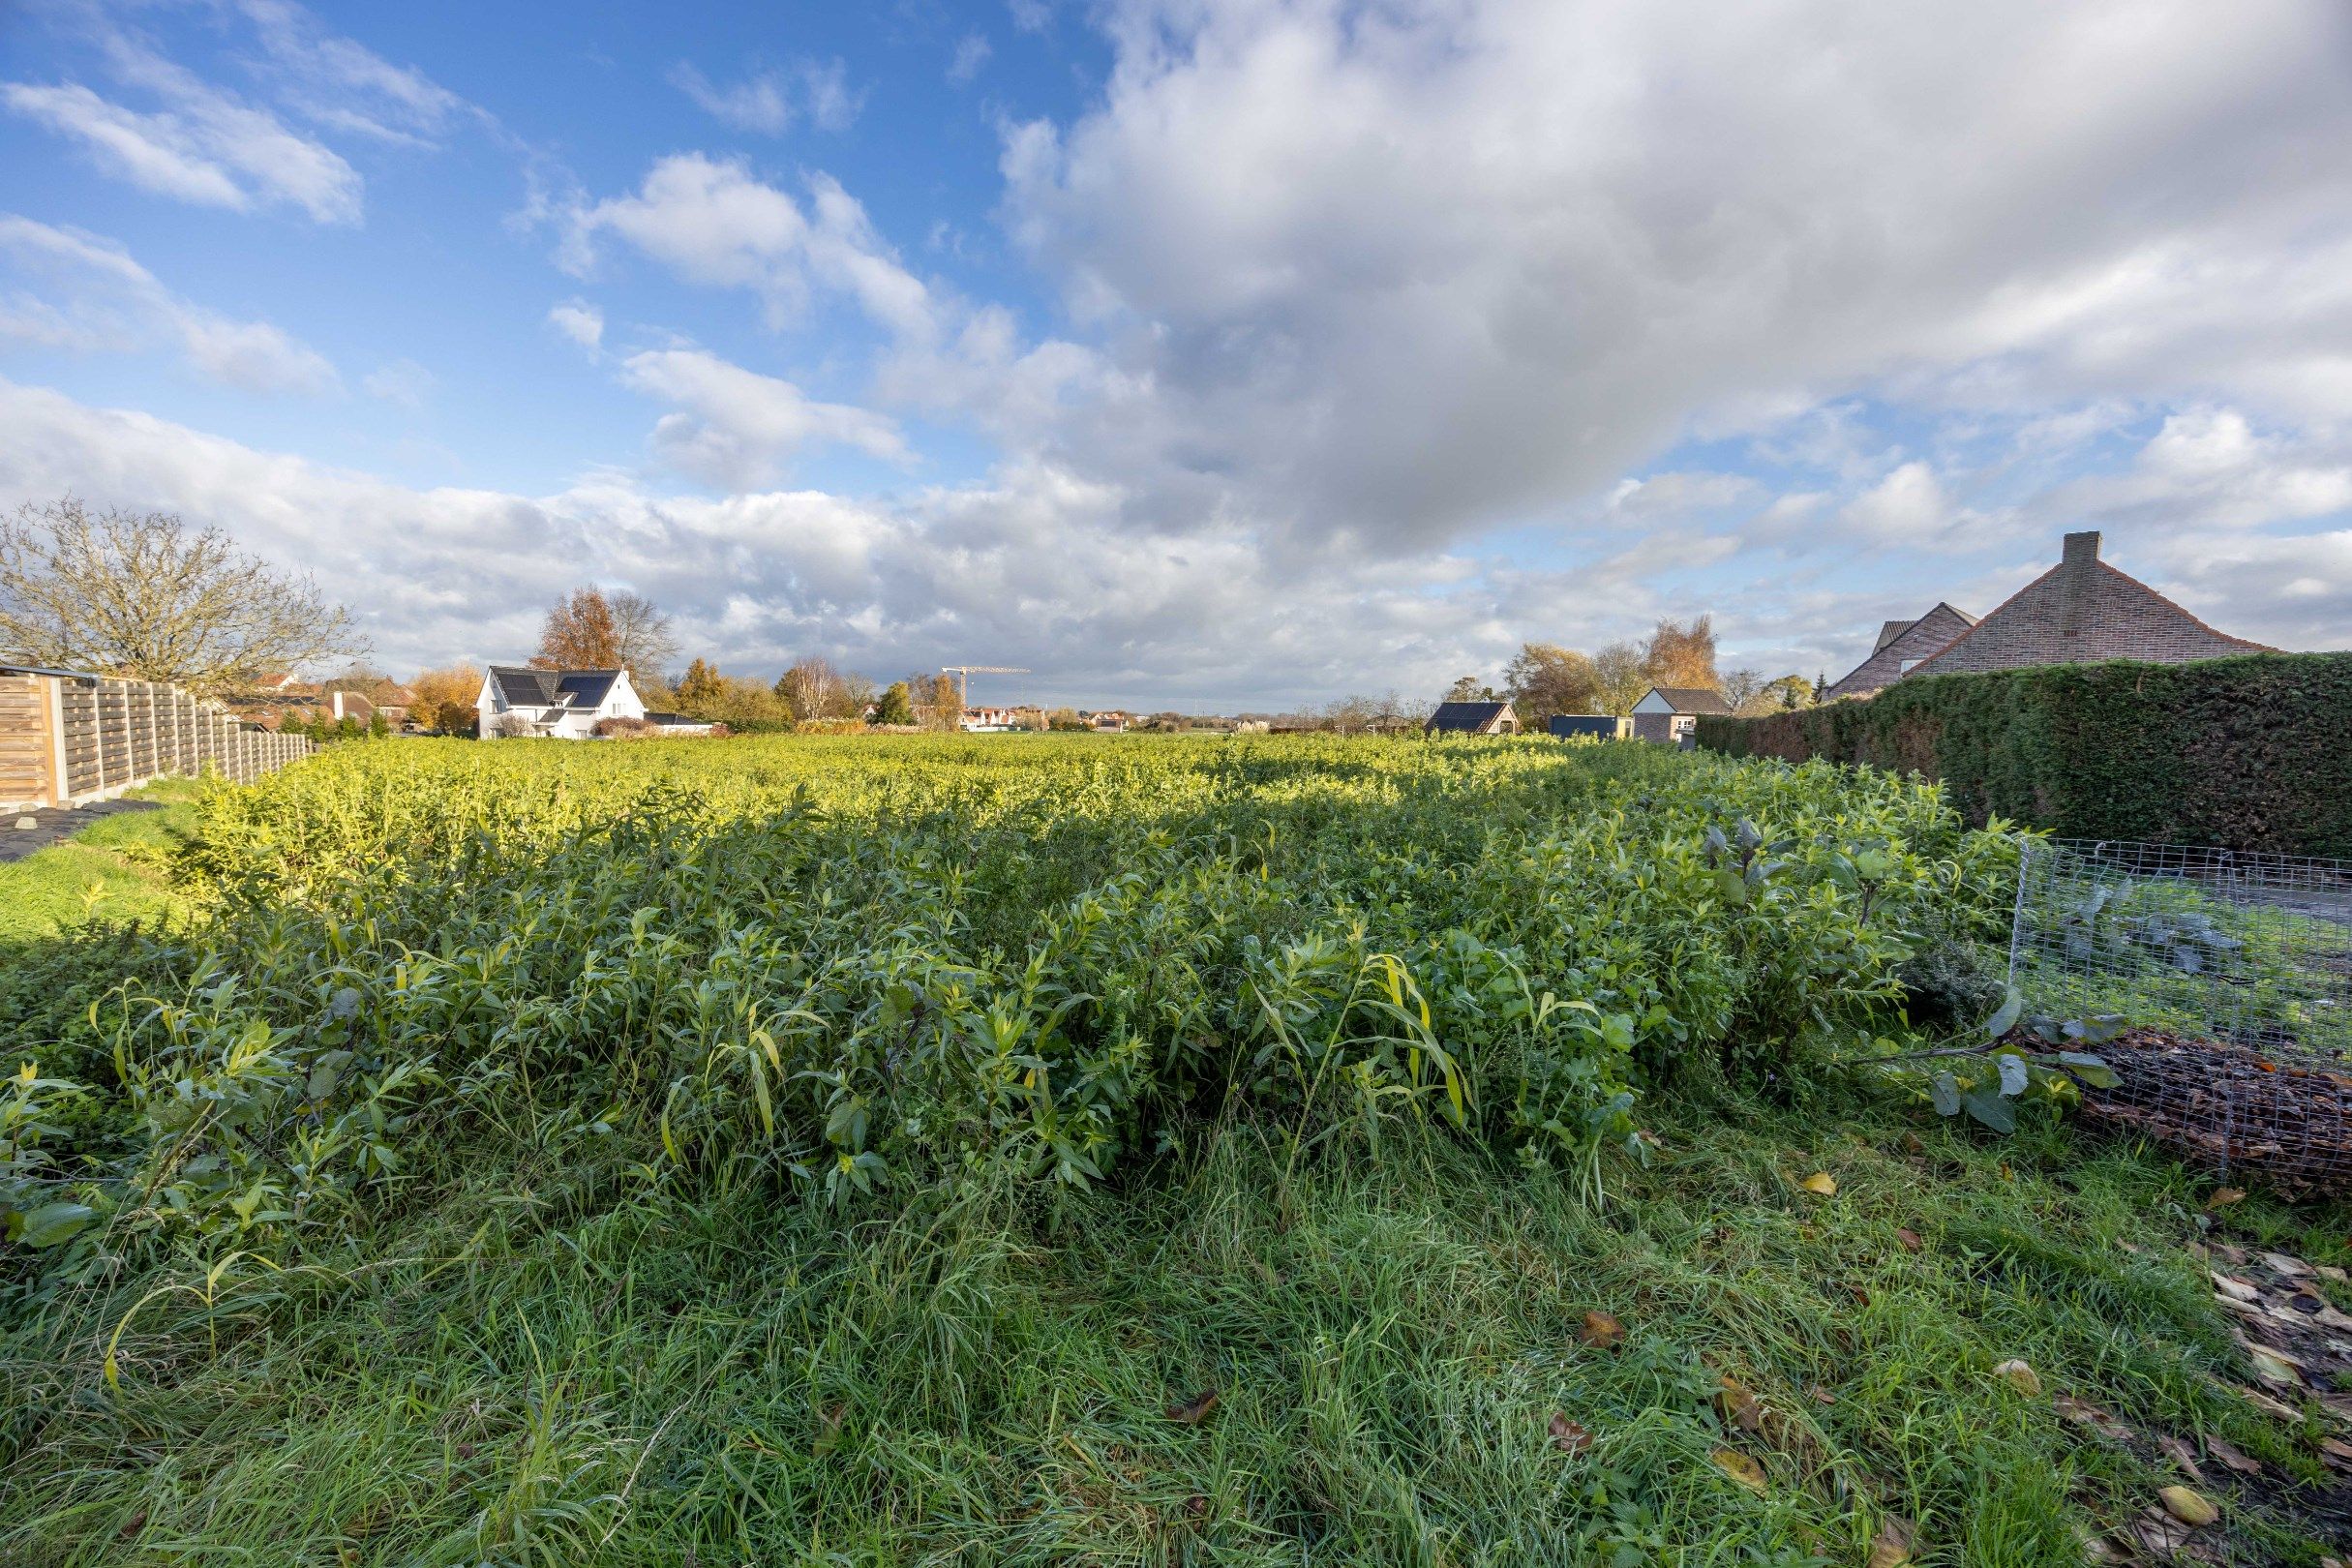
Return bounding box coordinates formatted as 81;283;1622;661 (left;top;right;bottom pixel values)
1913;533;2277;675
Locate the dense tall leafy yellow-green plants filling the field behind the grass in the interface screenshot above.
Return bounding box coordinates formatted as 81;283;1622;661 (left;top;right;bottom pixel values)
0;736;2006;1279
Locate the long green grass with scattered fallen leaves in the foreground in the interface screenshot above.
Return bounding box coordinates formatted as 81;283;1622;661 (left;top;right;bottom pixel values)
0;1102;2345;1566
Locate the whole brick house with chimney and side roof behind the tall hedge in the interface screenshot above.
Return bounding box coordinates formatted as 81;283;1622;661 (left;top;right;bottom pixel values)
1827;531;2277;698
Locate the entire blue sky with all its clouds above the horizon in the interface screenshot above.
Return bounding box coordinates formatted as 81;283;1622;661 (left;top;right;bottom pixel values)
0;0;2352;709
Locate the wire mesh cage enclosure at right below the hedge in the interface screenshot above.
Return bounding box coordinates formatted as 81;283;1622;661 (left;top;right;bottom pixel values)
2008;839;2352;1194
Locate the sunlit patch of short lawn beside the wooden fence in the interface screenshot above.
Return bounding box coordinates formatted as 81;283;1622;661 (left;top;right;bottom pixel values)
0;778;204;943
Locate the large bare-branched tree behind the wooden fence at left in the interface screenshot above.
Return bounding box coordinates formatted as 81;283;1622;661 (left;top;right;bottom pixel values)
0;496;367;693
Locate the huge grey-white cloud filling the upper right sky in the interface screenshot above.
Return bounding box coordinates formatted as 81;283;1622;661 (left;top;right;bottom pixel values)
1002;0;2352;550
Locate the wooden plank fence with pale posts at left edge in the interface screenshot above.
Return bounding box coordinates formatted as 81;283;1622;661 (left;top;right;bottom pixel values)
0;670;313;811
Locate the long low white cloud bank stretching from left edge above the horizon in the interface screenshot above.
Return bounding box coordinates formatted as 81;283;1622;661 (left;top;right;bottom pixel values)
0;380;1589;706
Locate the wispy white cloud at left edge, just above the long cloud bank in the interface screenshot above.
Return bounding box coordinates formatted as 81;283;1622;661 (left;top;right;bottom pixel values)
0;214;339;393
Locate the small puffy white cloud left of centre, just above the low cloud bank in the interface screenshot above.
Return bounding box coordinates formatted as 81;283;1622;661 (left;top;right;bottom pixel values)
621;347;908;492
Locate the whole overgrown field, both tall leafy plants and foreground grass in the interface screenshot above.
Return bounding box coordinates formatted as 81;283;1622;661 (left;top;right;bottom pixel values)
0;736;2342;1563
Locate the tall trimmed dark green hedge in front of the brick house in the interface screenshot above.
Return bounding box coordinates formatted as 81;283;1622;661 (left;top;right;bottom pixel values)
1698;653;2352;860
